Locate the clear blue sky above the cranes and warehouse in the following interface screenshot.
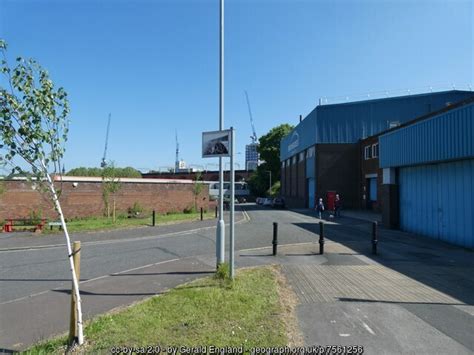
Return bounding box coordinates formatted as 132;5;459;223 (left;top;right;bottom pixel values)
0;0;474;169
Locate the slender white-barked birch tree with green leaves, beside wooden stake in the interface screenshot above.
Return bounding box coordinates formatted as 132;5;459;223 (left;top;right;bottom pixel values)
0;39;84;345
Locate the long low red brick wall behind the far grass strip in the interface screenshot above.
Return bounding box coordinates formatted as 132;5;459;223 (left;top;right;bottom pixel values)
0;181;209;221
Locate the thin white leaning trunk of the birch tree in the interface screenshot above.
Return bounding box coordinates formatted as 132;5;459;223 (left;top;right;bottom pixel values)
41;166;84;345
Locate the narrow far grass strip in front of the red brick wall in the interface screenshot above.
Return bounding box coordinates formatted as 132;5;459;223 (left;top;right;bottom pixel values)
43;212;214;234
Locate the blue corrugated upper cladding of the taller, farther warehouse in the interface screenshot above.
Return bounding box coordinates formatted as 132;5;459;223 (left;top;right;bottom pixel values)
280;90;473;161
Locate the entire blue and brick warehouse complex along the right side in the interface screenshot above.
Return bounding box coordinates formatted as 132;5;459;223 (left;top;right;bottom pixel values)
280;90;474;247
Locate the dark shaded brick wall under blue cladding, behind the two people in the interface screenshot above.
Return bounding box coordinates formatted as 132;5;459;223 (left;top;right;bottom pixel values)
316;143;359;208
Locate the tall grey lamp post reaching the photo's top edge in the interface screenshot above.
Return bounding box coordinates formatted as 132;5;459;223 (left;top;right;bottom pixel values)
216;0;225;265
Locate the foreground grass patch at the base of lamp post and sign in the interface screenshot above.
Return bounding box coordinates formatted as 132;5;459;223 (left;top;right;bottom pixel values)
26;267;288;353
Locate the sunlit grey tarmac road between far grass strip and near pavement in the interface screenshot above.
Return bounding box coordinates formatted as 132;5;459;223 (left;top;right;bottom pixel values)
0;205;315;304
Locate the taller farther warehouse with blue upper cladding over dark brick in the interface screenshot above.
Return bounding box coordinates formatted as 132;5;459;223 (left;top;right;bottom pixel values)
280;90;474;208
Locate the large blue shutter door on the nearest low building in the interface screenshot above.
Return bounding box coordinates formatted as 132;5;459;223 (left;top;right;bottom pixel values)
399;159;474;248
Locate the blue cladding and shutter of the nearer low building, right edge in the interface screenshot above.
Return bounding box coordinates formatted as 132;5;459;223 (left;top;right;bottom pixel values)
379;102;474;248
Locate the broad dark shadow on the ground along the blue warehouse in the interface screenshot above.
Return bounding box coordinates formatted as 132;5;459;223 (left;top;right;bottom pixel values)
293;218;474;305
